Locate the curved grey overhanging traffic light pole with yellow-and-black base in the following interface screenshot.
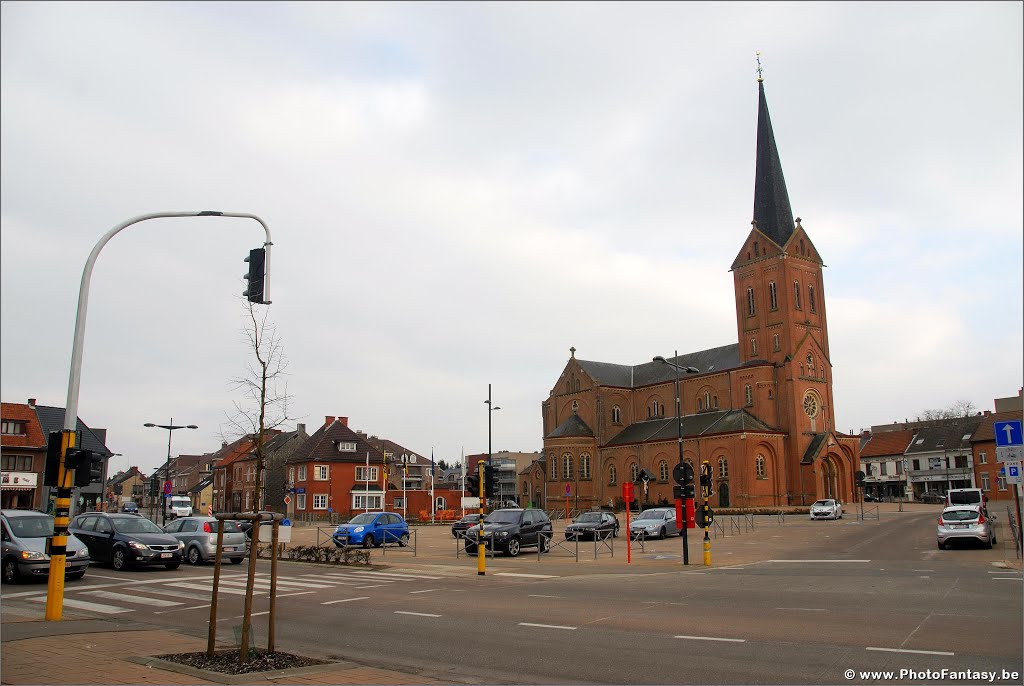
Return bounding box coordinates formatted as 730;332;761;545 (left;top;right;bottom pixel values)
46;210;273;621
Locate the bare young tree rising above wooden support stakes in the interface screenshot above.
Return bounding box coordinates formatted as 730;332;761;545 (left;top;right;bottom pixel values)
222;301;294;512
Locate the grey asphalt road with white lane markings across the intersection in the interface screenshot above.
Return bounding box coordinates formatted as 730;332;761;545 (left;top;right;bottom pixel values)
3;508;1024;684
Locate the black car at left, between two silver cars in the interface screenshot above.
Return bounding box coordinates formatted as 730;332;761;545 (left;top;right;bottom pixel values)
69;512;185;570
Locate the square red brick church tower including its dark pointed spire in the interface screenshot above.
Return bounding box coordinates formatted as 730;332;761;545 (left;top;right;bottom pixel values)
731;68;836;499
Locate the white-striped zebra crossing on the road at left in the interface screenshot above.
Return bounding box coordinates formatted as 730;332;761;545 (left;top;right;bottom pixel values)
25;570;442;614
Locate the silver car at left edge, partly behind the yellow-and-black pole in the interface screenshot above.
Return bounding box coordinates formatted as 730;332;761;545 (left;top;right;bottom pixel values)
0;510;89;584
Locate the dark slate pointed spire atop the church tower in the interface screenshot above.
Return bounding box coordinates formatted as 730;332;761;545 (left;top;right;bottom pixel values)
754;69;794;248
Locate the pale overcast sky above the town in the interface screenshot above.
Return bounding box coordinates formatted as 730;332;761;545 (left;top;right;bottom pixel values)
0;2;1024;479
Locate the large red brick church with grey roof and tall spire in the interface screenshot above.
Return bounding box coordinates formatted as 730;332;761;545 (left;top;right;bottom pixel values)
519;78;859;509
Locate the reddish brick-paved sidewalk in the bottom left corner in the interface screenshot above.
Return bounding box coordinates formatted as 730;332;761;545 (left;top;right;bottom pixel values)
0;607;442;685
